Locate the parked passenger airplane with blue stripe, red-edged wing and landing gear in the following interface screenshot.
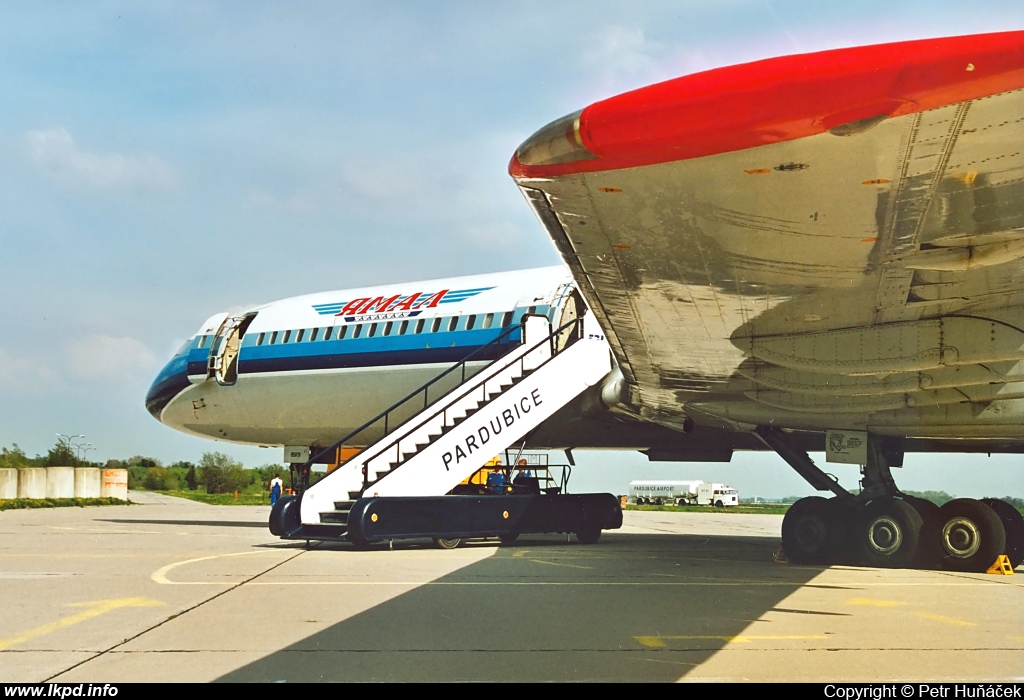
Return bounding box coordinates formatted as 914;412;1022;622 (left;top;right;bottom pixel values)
146;31;1024;571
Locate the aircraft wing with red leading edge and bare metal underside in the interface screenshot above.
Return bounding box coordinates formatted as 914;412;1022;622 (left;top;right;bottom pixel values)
511;33;1024;434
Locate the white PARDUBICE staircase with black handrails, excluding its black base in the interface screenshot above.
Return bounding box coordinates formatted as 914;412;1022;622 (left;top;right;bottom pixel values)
286;314;611;538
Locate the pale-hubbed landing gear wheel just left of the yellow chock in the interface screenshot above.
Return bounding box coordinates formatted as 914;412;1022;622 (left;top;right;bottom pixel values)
939;498;1007;571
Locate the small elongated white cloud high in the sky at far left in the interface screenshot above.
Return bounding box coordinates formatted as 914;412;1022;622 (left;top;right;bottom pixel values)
26;128;177;193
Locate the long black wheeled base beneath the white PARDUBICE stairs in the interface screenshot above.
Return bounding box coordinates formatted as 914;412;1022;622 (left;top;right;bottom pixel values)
280;493;623;544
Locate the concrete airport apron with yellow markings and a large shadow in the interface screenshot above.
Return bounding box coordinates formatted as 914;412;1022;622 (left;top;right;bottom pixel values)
0;492;1024;683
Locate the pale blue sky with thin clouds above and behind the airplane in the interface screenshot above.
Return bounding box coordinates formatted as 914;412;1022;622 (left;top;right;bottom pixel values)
0;0;1024;496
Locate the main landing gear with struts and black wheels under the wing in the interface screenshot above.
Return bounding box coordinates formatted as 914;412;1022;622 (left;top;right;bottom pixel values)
756;426;1024;571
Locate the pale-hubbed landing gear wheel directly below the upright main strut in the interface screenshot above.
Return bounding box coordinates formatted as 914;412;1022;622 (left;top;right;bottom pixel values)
855;496;923;569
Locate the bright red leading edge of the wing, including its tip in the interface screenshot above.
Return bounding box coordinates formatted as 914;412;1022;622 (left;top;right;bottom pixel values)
509;31;1024;177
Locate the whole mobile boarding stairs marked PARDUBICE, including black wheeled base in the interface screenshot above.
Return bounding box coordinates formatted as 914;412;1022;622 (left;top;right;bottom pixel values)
270;315;622;546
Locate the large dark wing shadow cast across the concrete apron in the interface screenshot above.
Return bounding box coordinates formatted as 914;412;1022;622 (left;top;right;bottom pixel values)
219;533;834;683
